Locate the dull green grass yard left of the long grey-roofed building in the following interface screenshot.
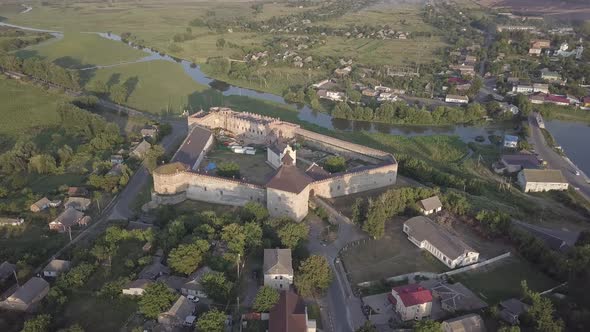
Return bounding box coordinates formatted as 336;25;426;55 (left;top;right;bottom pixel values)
342;218;448;284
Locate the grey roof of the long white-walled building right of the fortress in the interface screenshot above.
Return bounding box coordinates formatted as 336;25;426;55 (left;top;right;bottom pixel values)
404;216;475;260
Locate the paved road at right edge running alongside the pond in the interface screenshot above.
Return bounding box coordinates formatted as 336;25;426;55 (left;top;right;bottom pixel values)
529;114;590;200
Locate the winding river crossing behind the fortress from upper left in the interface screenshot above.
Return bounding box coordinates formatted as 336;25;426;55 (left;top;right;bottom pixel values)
0;22;513;142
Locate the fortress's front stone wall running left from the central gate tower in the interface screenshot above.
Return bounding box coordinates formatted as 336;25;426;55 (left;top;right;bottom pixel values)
154;172;266;206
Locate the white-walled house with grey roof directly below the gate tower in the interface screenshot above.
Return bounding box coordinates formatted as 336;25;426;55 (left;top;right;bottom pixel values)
263;249;293;290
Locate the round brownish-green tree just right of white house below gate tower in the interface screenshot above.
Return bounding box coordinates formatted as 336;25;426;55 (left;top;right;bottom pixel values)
295;255;333;297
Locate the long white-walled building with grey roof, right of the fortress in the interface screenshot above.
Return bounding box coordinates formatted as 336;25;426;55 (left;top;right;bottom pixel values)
403;216;479;269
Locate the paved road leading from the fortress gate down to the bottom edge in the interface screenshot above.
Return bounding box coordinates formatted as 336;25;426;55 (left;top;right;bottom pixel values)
308;198;367;332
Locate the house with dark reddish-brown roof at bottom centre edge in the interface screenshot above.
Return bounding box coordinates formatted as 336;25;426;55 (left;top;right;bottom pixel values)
268;291;316;332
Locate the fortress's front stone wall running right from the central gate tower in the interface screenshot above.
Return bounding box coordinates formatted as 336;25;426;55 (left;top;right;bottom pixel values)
310;164;397;198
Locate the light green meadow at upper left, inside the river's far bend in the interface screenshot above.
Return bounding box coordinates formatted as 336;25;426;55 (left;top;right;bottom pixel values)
17;32;147;68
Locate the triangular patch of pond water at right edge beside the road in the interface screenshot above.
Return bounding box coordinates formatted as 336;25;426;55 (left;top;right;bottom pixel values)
545;120;590;175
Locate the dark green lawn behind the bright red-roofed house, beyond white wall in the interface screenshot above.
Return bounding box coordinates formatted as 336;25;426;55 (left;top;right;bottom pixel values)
453;257;558;305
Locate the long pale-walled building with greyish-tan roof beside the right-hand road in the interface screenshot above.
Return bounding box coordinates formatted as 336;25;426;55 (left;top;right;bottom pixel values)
518;169;569;193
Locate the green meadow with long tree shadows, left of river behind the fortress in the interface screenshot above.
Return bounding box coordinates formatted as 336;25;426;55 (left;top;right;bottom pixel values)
84;60;205;114
